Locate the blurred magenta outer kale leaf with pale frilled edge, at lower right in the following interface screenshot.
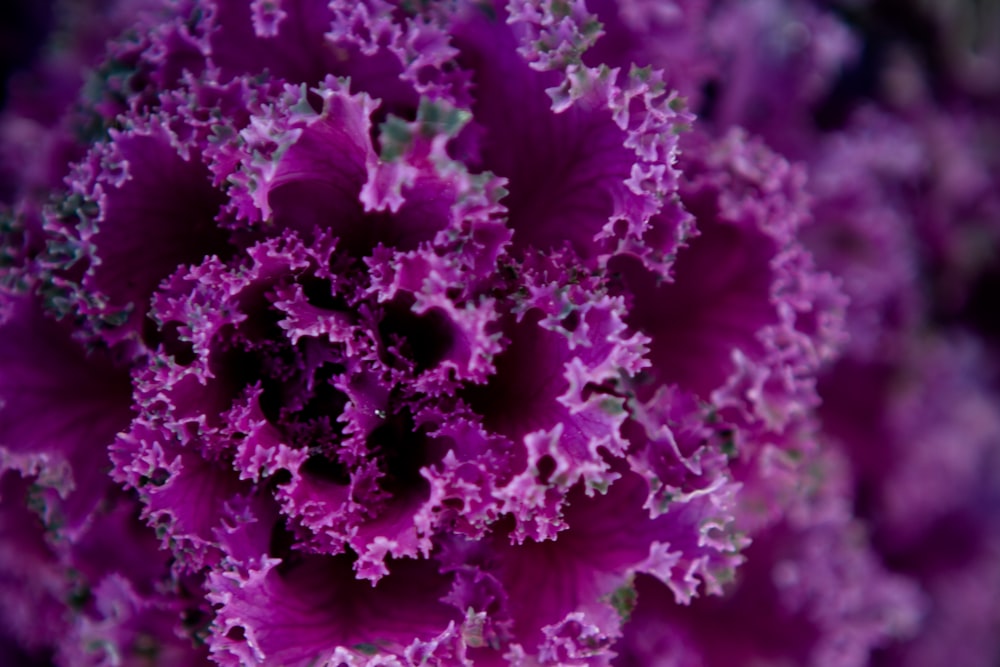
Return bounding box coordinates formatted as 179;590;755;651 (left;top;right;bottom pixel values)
614;457;927;667
